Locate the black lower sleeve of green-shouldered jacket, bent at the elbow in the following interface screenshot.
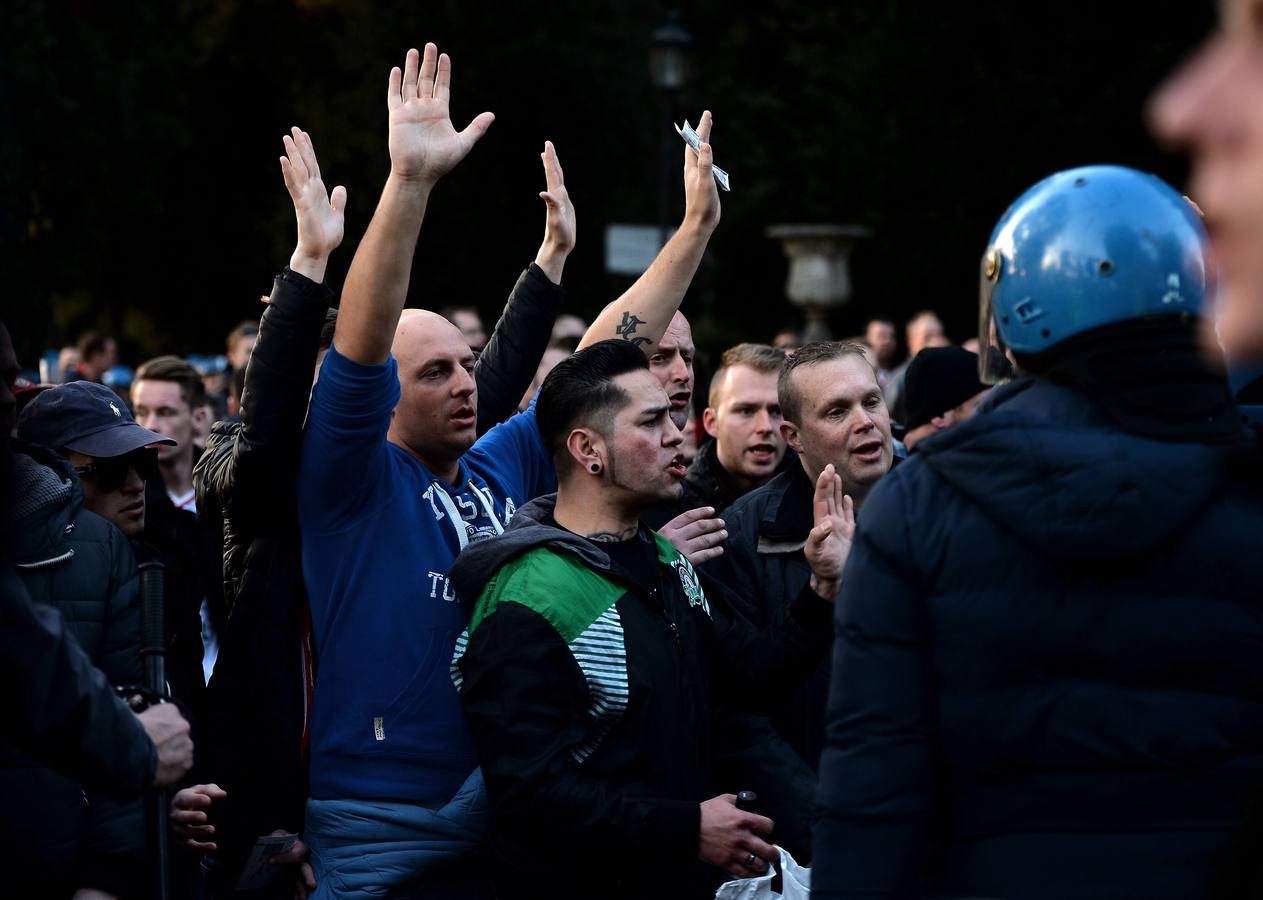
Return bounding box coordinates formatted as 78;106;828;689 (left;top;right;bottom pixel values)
458;603;701;871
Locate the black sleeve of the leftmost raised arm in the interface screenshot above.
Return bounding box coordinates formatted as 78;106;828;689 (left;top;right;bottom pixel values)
195;268;333;527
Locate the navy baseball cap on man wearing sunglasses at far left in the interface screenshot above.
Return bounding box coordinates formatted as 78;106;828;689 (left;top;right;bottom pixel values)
18;381;176;457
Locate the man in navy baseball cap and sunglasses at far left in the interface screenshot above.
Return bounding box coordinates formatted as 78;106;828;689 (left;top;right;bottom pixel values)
9;382;180;896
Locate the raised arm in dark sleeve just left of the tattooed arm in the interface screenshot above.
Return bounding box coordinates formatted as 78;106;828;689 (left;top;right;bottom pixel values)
474;141;576;434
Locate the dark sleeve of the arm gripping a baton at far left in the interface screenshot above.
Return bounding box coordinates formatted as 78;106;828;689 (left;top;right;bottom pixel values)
0;568;158;799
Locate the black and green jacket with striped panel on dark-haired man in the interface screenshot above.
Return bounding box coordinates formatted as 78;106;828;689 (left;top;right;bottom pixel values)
451;497;832;897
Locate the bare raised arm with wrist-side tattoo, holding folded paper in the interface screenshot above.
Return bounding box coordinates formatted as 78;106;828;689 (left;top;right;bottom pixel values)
578;110;720;353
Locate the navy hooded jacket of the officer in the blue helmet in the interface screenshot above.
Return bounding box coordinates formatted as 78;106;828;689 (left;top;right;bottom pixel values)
812;379;1263;900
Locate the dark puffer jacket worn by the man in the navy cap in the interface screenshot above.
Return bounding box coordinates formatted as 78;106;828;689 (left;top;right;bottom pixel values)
0;447;144;895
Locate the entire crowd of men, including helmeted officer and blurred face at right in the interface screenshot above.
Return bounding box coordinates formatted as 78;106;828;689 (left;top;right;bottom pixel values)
7;8;1263;900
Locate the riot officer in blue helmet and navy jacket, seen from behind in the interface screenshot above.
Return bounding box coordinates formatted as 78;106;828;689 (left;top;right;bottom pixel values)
812;167;1263;900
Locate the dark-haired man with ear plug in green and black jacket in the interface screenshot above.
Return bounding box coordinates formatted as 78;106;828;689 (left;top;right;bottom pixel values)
452;340;847;897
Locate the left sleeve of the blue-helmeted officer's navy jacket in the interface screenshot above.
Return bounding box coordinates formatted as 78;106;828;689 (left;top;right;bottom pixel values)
811;476;937;897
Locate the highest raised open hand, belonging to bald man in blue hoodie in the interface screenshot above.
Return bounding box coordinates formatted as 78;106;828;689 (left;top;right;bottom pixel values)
386;44;495;184
